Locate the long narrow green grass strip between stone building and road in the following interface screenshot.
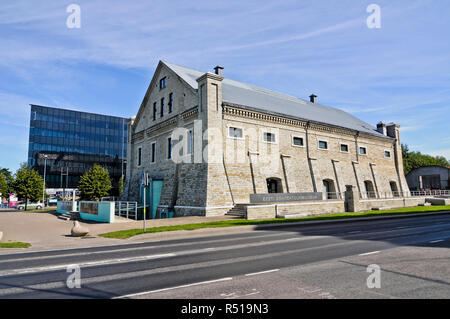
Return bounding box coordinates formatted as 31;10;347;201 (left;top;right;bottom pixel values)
99;206;450;239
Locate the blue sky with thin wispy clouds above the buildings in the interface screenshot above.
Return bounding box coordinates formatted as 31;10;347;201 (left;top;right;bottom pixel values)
0;0;450;171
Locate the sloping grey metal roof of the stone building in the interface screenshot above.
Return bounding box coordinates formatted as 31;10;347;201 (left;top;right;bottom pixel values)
162;61;386;138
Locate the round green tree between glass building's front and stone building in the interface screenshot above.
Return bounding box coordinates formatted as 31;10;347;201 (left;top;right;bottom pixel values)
78;164;112;201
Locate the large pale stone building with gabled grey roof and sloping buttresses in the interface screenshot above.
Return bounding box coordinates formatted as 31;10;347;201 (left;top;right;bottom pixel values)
124;61;409;216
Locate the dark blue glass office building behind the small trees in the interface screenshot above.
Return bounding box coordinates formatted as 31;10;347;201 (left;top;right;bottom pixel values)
28;105;127;195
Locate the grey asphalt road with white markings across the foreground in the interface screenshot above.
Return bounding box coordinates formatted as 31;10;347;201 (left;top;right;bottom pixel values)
0;215;450;299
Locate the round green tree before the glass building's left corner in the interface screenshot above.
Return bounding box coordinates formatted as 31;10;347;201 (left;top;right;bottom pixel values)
13;164;44;210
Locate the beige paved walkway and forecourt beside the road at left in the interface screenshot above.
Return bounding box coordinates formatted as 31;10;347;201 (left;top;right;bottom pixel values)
0;210;239;254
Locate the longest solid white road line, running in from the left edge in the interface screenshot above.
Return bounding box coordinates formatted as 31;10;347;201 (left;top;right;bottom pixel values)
0;254;176;277
